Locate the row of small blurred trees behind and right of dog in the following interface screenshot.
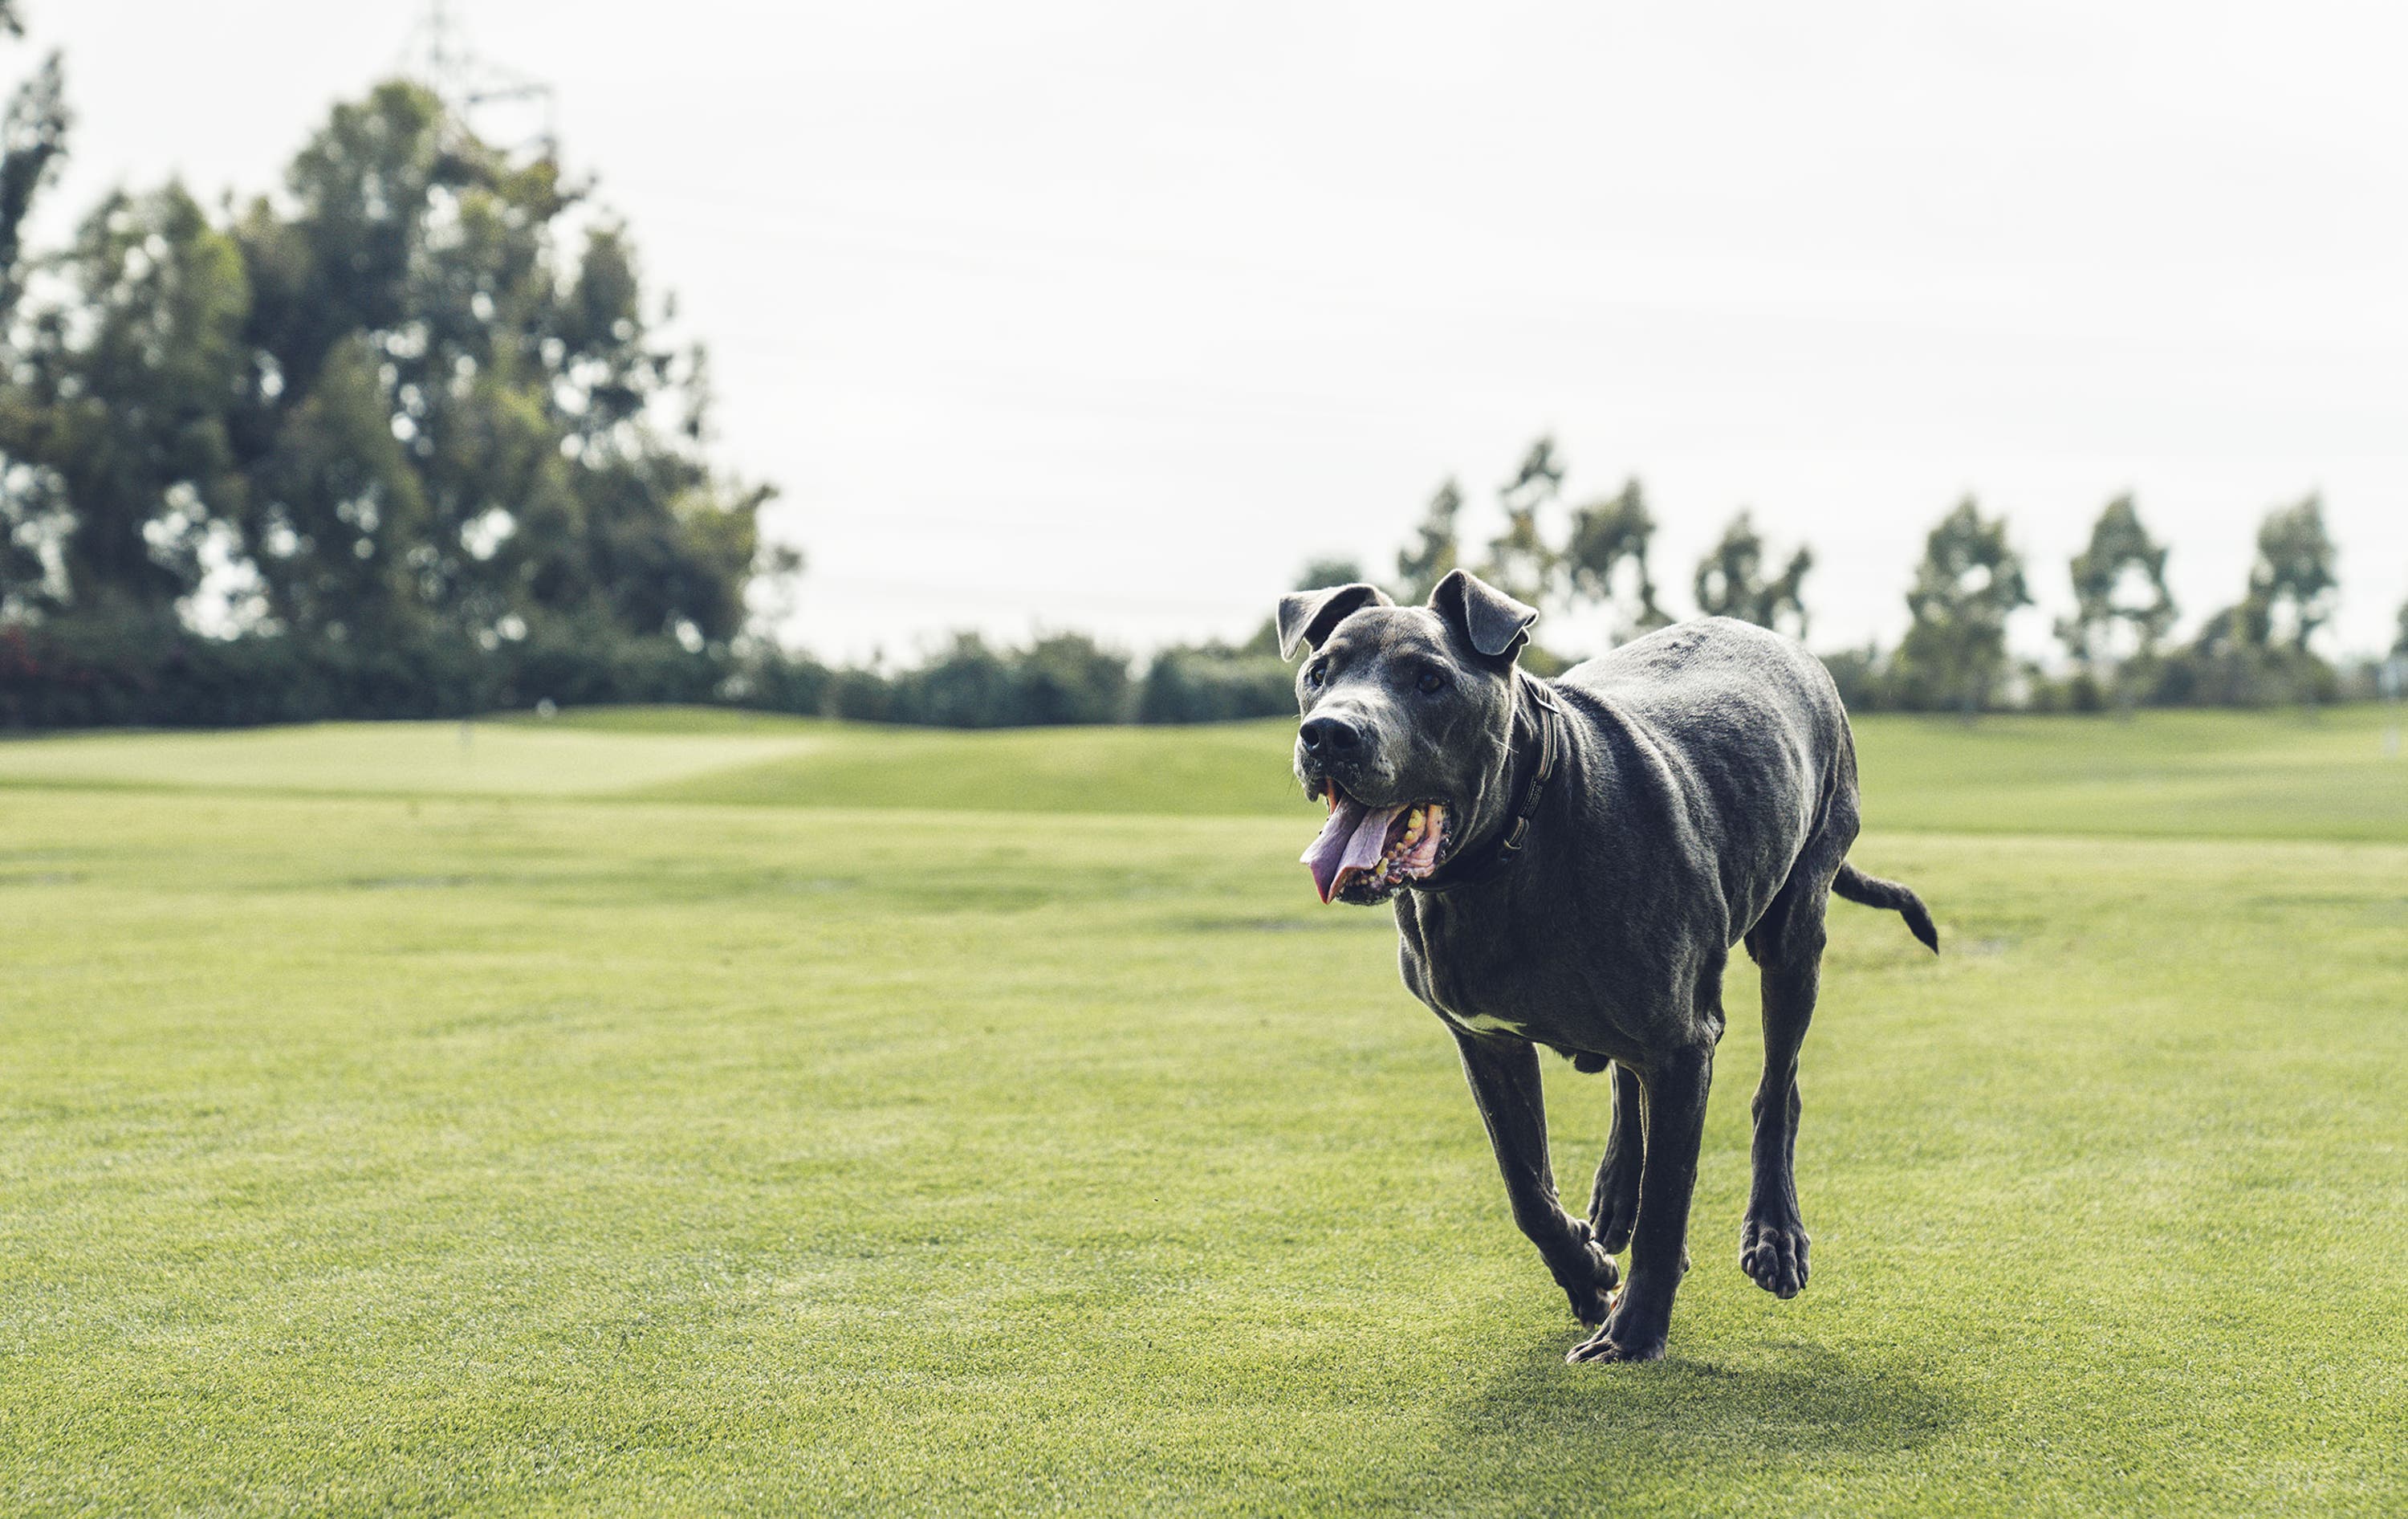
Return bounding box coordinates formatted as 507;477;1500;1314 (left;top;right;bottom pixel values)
1194;438;2379;715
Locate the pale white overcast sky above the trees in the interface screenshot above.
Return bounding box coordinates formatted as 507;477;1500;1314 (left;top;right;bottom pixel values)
17;0;2408;655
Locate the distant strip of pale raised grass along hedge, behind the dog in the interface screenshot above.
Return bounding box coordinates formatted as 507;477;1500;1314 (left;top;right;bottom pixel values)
0;708;2408;842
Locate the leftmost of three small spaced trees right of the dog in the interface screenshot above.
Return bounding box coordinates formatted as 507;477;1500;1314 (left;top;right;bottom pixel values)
1898;496;2032;718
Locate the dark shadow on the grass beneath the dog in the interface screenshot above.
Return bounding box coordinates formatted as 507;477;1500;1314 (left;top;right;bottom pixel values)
1454;1336;1965;1485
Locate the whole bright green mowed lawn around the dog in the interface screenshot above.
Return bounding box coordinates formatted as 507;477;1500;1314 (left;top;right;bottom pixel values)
0;711;2408;1514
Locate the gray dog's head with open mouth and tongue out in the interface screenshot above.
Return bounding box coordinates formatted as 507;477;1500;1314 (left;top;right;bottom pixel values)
1279;571;1539;905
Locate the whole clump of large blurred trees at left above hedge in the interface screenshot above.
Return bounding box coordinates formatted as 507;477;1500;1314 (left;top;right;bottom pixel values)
0;82;799;650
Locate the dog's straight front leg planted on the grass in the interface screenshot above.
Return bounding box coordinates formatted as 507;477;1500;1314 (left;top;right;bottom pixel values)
1568;1045;1714;1360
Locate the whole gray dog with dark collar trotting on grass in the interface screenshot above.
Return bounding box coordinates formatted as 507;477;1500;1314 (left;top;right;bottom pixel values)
1279;571;1938;1360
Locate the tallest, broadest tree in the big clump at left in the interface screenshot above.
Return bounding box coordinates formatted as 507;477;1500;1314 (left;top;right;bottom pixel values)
241;82;771;641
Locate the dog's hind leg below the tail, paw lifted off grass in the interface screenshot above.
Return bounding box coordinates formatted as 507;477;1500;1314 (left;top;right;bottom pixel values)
1739;864;1830;1297
